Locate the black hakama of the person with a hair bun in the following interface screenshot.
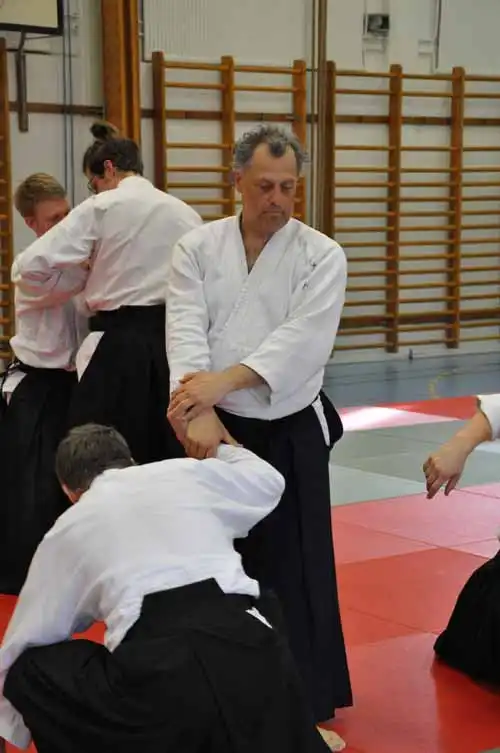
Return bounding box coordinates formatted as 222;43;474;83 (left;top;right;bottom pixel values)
70;306;184;463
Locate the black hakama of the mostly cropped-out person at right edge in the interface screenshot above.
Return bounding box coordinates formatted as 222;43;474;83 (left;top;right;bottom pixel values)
434;552;500;686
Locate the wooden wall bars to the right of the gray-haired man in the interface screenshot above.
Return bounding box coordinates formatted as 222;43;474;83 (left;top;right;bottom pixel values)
323;65;500;353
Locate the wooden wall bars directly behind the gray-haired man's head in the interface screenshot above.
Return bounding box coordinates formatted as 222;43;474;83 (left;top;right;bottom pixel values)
153;52;307;220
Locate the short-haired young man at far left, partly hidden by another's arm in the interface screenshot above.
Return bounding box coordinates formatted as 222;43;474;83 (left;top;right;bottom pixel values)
0;173;87;594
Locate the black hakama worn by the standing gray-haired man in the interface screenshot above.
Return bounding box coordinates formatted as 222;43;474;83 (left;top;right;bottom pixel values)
218;394;352;723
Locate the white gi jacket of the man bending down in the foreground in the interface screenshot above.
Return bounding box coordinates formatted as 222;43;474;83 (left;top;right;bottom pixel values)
0;445;285;748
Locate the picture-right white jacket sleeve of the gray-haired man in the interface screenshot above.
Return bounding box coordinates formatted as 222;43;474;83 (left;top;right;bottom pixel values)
242;243;347;403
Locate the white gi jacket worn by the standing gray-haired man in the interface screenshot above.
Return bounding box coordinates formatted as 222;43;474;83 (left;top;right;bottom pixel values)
167;217;347;428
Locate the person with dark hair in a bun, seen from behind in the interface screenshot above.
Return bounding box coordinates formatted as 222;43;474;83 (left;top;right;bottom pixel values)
12;122;202;463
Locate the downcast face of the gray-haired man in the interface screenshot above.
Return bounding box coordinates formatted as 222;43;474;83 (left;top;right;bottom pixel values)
235;144;299;235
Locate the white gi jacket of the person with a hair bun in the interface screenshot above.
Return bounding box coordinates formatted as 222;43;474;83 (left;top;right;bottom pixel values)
12;176;202;375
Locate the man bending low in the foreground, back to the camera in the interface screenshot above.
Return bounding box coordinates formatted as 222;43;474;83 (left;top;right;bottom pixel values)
0;424;327;753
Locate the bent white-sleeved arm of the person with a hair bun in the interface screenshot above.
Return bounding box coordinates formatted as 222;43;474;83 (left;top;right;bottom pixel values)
11;198;99;307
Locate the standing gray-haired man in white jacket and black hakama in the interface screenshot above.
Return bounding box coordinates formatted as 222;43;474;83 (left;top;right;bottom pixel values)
167;125;352;736
